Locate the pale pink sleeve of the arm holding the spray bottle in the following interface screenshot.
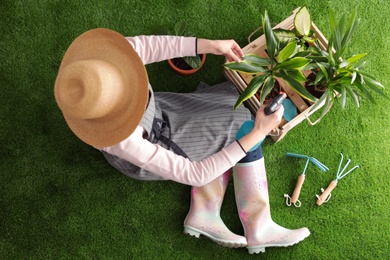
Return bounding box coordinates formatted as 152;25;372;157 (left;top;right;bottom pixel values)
102;126;245;186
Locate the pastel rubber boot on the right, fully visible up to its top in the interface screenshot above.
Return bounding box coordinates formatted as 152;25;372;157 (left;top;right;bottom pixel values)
233;157;310;254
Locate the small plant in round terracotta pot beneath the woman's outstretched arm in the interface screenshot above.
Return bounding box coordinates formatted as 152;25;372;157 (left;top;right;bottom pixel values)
166;22;206;76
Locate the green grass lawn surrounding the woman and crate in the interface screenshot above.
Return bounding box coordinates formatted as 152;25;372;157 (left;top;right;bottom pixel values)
0;0;390;259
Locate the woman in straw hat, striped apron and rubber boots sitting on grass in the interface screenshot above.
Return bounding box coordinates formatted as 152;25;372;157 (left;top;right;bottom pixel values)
54;29;310;253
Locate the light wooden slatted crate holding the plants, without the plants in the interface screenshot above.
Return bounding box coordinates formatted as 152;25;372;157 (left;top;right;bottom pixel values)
224;8;328;142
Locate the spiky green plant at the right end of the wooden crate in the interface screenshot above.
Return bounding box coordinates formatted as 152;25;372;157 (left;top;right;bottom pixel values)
306;9;386;118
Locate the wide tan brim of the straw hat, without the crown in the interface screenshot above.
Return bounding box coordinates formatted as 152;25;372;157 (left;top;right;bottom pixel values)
55;28;148;148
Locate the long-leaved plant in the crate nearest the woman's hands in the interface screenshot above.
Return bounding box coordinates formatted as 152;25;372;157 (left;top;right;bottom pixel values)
224;8;316;108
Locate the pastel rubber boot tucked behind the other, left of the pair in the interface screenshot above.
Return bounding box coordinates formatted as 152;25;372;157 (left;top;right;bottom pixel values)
184;171;247;248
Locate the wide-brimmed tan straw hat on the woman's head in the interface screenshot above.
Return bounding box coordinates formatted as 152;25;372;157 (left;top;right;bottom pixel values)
54;28;148;148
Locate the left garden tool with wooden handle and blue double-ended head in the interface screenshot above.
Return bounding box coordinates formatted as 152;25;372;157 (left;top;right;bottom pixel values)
284;153;329;207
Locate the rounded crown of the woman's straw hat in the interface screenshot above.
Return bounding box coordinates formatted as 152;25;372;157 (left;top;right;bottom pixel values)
55;59;125;119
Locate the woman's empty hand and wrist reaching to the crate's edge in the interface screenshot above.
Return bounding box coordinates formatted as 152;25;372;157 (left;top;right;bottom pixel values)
197;39;244;62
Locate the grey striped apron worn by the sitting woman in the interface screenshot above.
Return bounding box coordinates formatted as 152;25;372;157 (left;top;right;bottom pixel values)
102;82;251;180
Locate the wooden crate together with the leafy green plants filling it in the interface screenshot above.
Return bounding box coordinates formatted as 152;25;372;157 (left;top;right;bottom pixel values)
225;7;384;141
